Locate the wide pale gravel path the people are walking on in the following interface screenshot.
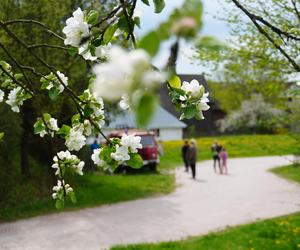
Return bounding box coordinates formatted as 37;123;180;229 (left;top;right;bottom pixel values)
0;157;300;250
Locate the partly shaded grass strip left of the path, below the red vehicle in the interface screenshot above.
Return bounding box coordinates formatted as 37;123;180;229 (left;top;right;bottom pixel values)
0;174;175;221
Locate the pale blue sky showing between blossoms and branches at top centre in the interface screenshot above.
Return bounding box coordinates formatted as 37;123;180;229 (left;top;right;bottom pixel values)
137;0;234;74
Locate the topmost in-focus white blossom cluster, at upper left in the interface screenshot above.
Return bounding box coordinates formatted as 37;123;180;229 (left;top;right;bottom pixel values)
63;8;90;47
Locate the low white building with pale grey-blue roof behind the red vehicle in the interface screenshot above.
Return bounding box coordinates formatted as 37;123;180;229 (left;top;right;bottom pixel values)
103;106;186;141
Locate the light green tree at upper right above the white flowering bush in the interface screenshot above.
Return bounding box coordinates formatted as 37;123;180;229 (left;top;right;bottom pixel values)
195;0;300;127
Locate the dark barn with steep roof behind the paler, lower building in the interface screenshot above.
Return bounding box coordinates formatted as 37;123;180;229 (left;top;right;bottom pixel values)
160;74;225;137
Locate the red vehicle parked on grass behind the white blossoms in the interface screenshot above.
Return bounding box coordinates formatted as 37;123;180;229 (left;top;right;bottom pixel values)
108;129;159;171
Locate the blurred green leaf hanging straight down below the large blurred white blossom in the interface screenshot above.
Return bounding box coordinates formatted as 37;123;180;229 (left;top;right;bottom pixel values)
136;93;157;127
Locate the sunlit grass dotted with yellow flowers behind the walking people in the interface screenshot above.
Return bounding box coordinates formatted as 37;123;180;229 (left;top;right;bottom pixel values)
160;135;296;169
